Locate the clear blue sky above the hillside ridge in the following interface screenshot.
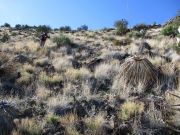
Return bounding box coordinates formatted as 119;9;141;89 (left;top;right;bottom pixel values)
0;0;180;29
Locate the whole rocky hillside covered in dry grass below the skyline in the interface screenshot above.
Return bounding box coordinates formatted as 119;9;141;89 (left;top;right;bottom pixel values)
0;19;180;135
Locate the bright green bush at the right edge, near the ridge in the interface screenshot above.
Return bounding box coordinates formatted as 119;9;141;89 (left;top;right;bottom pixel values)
161;25;178;36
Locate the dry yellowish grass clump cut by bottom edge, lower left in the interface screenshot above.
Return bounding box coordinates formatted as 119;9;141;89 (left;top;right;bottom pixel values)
12;118;43;135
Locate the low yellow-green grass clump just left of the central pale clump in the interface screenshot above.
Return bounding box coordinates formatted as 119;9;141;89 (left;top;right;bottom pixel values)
39;72;63;85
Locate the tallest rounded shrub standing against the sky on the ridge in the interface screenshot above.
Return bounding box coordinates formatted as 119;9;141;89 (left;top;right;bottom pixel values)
114;19;128;35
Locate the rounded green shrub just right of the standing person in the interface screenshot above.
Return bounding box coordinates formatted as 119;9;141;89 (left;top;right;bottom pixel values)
53;35;72;47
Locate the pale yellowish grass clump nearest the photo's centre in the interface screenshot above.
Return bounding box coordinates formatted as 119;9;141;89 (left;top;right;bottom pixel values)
65;68;91;81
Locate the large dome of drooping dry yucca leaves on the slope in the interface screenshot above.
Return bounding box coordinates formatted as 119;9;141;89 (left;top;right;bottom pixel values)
118;56;158;90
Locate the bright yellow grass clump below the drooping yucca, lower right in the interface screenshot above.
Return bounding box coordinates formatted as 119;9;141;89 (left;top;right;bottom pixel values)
118;101;144;120
